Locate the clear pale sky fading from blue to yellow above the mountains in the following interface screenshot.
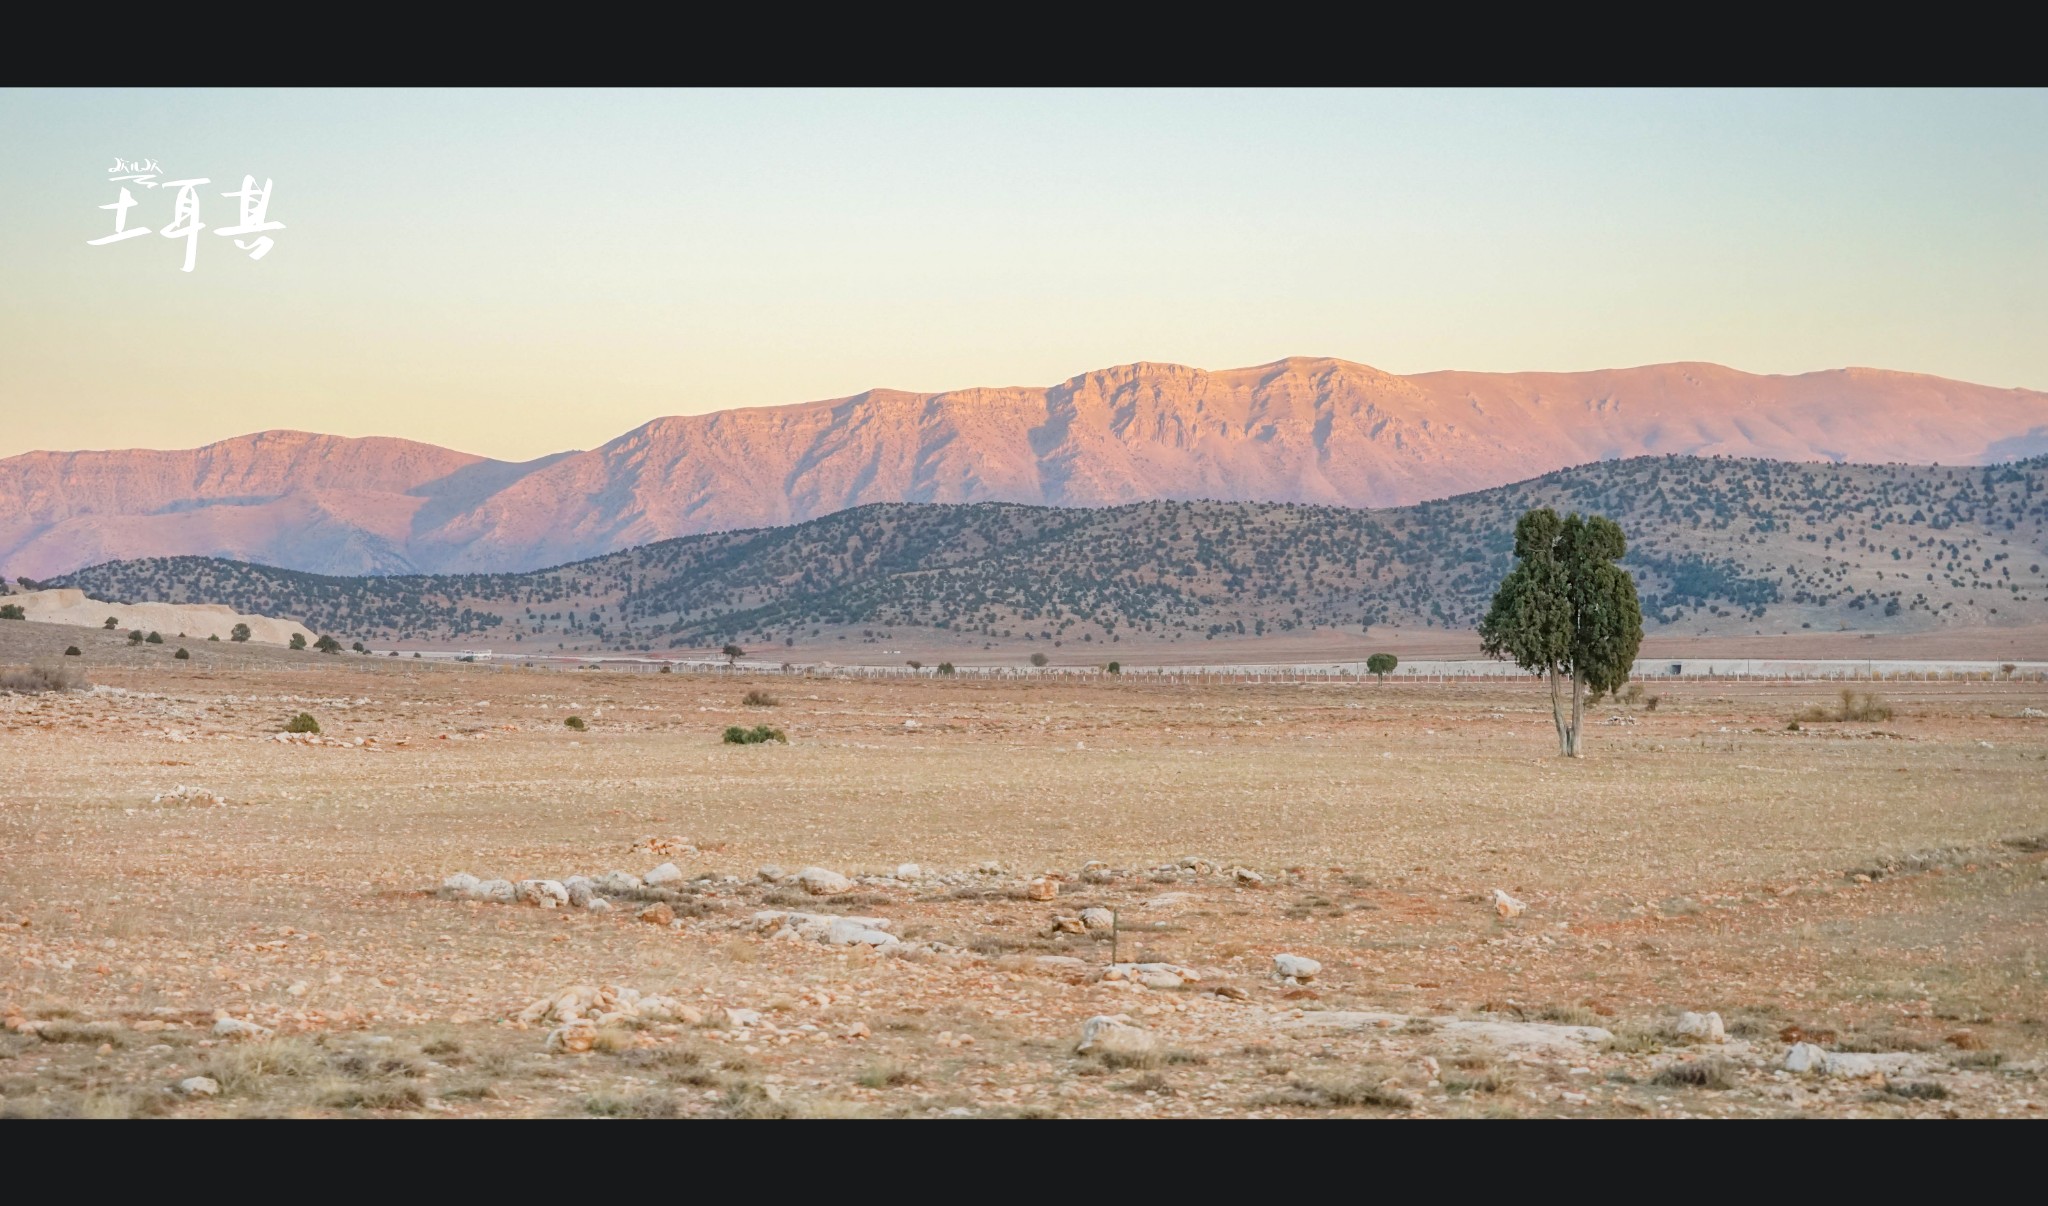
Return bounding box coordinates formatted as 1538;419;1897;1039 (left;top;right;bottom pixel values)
0;90;2048;459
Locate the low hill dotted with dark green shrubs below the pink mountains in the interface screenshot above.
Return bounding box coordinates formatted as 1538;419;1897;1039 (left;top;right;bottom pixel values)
49;457;2048;651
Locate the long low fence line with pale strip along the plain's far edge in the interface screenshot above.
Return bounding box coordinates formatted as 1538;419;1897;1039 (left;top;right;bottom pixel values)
368;653;2048;686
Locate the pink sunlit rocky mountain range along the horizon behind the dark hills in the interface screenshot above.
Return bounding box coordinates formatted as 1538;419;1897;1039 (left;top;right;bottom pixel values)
0;358;2048;577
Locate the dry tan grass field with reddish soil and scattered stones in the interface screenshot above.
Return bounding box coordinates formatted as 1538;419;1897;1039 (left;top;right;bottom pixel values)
0;624;2048;1118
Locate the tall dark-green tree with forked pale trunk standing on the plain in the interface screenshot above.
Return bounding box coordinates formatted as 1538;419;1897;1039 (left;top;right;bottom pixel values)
1479;508;1642;758
